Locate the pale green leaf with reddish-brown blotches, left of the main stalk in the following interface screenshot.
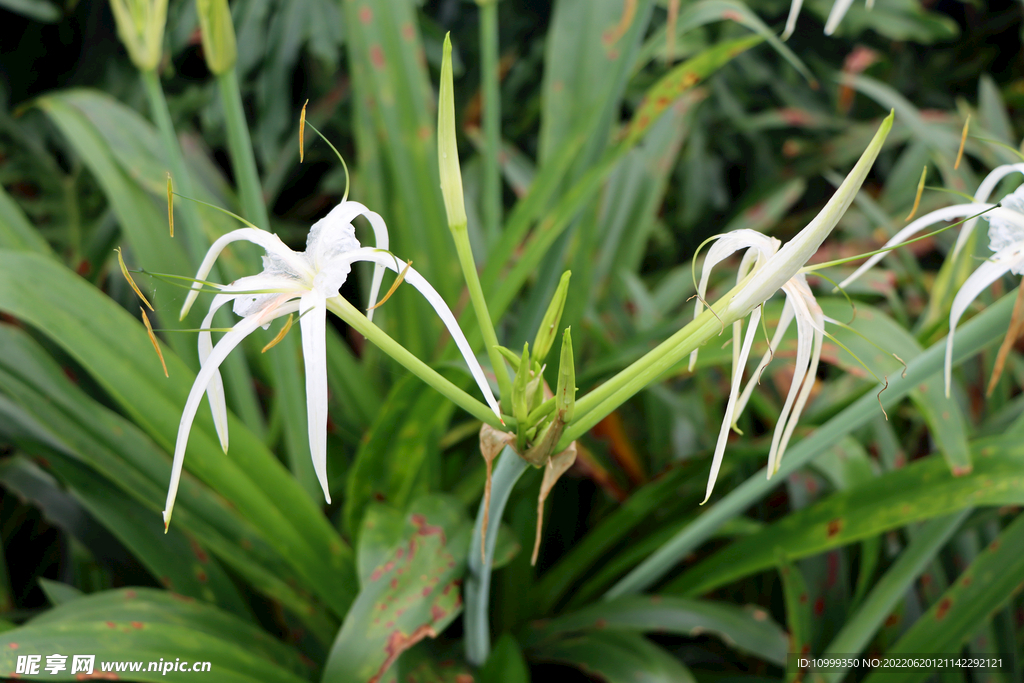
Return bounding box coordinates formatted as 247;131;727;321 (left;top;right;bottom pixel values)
323;496;471;683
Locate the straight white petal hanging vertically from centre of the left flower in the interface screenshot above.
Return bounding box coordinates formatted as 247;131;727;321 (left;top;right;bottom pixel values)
299;290;331;503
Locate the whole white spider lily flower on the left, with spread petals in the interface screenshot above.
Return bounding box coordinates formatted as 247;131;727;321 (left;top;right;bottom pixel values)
164;202;501;526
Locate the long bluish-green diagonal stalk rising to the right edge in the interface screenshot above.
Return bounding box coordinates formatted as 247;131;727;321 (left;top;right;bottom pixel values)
604;294;1016;600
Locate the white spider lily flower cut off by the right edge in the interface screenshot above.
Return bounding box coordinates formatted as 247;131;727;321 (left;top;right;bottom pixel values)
840;164;1024;397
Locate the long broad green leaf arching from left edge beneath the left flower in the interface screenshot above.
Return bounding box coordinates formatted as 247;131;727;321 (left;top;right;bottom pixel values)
0;252;356;614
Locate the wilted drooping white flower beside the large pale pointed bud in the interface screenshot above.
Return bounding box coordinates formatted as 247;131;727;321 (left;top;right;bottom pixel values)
690;229;826;503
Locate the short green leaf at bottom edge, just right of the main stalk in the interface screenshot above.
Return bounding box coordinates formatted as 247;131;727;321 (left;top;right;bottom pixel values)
531;631;695;683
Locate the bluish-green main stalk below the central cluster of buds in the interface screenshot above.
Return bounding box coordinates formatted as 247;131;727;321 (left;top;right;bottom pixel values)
464;446;526;667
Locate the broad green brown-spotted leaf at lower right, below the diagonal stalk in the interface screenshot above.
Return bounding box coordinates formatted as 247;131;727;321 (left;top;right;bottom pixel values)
667;438;1024;595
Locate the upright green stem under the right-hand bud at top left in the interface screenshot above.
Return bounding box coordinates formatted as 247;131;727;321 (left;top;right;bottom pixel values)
217;67;270;230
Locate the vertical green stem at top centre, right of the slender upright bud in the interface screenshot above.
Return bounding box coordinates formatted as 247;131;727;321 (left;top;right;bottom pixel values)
480;0;502;248
